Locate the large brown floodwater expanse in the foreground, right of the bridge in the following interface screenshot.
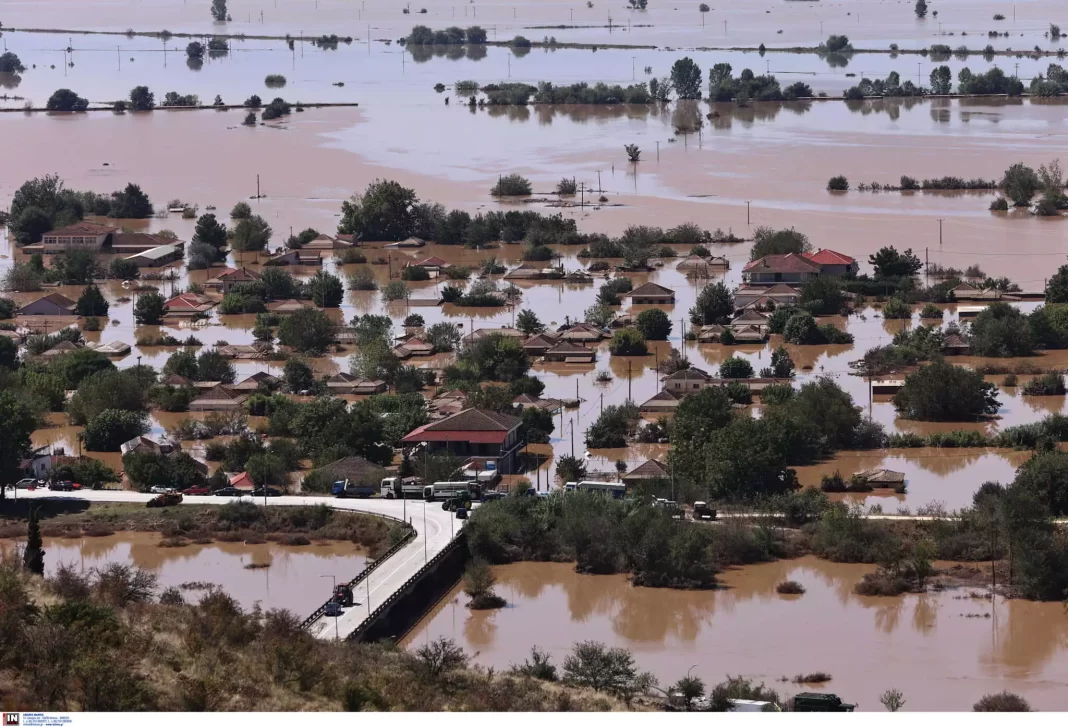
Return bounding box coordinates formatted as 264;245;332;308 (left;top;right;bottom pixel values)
406;557;1068;711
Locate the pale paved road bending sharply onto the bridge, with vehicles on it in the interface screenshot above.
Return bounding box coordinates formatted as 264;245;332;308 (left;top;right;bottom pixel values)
7;490;465;638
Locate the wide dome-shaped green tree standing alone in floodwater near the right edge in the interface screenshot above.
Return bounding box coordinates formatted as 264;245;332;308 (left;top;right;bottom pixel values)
894;361;999;422
